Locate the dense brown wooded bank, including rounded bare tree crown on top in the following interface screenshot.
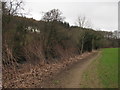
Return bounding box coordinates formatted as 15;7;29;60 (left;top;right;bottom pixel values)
2;2;120;87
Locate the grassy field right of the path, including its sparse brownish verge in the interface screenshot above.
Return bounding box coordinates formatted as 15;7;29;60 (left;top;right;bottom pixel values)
82;48;118;88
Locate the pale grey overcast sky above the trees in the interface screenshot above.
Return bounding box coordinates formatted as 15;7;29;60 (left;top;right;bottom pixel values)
24;0;118;31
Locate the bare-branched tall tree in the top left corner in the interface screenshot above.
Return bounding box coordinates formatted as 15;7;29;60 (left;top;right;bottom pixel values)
2;0;23;27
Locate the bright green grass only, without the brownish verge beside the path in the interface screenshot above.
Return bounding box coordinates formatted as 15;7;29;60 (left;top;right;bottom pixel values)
97;48;118;88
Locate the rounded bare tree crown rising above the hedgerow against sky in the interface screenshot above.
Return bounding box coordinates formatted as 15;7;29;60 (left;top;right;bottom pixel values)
42;9;65;21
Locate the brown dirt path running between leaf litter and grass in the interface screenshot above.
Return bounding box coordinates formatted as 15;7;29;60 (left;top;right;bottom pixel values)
47;52;99;88
